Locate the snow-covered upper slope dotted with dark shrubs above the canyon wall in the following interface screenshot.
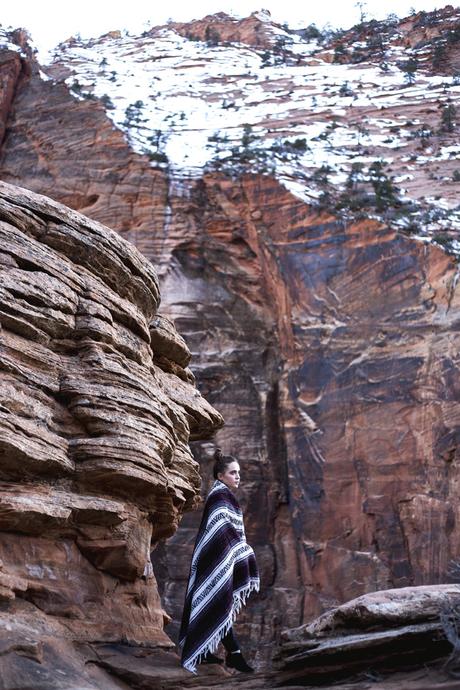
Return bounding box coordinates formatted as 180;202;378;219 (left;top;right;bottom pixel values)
25;8;460;251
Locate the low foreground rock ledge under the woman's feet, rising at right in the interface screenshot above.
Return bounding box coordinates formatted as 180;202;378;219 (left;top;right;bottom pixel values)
68;585;460;690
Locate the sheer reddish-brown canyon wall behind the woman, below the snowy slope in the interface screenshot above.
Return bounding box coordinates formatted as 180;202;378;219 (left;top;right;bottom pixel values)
0;26;460;661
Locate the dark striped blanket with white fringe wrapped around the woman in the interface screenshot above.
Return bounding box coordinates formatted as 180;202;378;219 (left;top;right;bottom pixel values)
179;480;259;673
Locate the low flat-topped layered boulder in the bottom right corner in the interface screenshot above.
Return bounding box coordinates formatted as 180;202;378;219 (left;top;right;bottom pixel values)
277;585;460;687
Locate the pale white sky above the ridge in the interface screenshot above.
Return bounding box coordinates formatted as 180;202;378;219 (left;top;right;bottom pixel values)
0;0;448;61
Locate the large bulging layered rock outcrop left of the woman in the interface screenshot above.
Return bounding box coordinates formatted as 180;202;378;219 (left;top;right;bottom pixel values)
0;183;222;688
